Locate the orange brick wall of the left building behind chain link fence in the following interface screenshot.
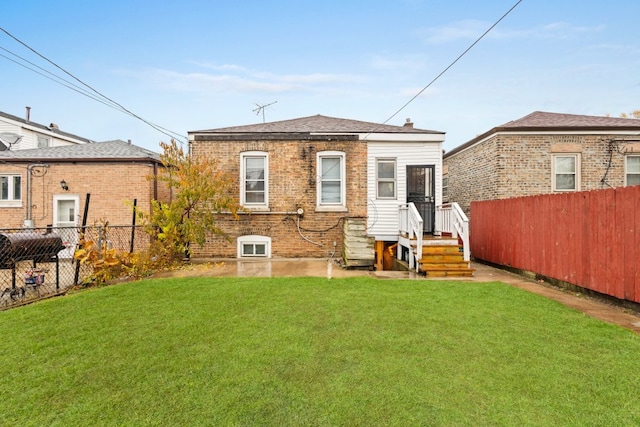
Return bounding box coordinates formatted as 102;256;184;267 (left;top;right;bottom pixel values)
0;162;168;228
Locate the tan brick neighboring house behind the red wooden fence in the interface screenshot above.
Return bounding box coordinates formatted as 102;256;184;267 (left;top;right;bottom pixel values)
443;111;640;215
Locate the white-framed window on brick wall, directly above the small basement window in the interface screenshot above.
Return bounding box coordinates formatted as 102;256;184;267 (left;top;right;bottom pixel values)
240;151;269;208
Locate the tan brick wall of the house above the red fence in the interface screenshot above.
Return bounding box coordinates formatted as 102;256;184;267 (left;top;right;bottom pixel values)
444;134;636;214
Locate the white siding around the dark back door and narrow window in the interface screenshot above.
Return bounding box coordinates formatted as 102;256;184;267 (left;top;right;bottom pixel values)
367;141;442;241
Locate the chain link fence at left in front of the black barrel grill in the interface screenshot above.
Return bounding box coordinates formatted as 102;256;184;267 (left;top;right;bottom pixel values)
0;225;150;310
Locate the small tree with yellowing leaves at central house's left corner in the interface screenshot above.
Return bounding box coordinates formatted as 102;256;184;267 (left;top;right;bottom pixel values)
140;140;239;262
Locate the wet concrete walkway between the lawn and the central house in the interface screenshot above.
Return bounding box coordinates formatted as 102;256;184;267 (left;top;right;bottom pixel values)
166;258;640;333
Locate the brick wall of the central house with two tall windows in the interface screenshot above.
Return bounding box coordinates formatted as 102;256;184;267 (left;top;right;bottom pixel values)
192;138;367;258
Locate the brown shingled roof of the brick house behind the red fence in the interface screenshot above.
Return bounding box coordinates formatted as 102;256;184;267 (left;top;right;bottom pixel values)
444;111;640;157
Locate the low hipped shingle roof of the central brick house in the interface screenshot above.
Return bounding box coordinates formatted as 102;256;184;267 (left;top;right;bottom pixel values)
189;114;444;135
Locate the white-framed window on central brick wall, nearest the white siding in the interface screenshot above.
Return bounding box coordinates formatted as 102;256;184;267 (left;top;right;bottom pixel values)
317;151;346;210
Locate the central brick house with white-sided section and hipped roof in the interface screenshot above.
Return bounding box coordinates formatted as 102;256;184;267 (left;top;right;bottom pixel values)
189;115;444;261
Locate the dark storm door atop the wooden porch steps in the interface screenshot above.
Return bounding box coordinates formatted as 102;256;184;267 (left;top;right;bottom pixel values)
407;165;436;234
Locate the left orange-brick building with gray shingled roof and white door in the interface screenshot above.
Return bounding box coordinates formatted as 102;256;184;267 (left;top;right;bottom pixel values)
0;140;169;232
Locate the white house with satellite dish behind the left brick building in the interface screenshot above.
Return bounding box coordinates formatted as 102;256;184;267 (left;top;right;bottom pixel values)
0;107;93;151
